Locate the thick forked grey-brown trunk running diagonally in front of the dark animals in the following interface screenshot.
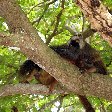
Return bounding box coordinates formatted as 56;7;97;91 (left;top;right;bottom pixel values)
0;0;112;100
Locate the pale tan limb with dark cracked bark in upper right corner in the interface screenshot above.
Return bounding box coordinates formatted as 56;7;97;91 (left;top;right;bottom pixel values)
75;0;112;46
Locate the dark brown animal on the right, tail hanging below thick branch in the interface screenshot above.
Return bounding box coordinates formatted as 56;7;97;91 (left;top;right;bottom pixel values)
66;38;108;112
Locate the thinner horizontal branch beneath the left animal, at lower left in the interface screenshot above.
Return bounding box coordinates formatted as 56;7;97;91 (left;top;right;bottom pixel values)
0;84;65;97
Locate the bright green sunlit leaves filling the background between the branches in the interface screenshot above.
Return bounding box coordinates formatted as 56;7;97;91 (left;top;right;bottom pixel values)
0;0;112;112
